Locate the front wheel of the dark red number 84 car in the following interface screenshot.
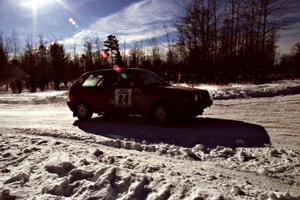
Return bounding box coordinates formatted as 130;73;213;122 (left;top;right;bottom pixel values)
151;103;171;125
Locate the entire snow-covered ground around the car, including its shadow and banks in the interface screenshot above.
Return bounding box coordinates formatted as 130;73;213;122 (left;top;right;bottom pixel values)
0;80;300;200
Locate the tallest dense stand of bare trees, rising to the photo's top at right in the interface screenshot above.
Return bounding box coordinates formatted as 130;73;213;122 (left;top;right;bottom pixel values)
176;0;299;82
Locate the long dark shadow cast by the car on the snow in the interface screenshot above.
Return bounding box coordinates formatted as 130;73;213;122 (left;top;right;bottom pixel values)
73;116;270;148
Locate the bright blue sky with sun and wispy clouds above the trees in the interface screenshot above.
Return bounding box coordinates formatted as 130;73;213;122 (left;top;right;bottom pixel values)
0;0;300;53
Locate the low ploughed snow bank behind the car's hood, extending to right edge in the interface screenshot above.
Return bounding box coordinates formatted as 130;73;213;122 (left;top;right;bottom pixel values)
178;79;300;100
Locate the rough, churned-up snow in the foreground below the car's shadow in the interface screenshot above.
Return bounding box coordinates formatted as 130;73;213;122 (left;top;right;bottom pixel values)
0;129;300;200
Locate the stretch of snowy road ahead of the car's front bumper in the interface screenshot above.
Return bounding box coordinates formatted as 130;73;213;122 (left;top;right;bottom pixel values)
204;95;300;150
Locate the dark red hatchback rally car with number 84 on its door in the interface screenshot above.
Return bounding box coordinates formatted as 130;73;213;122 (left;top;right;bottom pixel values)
67;68;212;124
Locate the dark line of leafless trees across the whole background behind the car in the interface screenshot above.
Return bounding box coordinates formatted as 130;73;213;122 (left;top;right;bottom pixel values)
0;0;300;92
